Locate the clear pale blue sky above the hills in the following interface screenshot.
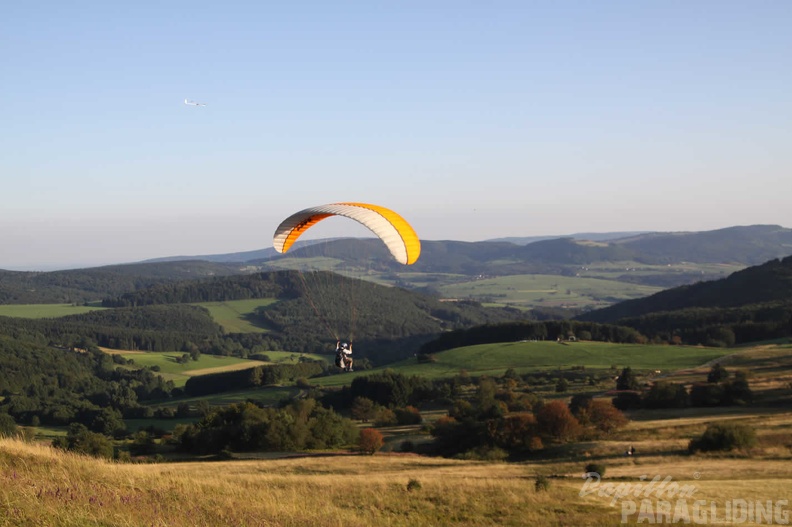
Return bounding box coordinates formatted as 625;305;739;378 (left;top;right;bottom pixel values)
0;0;792;269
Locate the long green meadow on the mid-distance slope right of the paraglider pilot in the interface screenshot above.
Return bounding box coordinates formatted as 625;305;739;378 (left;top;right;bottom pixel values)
311;341;733;386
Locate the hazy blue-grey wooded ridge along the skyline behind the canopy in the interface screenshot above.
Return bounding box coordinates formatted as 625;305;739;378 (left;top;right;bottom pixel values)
138;225;792;274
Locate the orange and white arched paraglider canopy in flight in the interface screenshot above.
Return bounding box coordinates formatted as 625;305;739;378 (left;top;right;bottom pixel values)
272;202;421;265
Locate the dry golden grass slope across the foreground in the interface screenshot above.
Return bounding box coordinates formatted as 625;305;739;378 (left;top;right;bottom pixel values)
0;439;792;527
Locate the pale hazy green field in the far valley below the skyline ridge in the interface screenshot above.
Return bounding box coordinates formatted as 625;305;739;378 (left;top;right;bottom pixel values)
437;274;662;308
